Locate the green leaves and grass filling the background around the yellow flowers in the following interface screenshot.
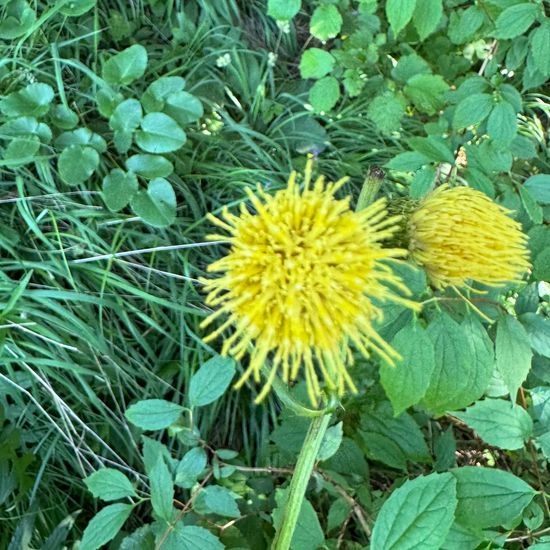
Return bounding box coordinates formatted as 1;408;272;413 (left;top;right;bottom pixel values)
0;0;550;550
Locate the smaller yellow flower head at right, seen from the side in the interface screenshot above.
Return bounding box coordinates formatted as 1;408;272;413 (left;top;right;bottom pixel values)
408;185;529;288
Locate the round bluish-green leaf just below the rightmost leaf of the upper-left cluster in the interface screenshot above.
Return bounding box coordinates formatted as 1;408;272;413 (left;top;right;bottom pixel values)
135;113;187;153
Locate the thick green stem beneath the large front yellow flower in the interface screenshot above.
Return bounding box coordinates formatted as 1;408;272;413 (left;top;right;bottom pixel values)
271;412;332;550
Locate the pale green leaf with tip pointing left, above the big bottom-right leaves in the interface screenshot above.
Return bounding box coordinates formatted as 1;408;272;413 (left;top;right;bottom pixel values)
452;399;533;450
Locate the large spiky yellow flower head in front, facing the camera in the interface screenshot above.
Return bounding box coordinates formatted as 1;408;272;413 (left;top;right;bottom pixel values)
202;162;416;403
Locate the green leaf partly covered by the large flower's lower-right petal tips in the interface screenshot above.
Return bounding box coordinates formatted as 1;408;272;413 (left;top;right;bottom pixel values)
380;322;435;416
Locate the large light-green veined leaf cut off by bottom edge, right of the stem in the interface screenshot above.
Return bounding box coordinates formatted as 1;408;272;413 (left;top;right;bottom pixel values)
371;473;457;550
